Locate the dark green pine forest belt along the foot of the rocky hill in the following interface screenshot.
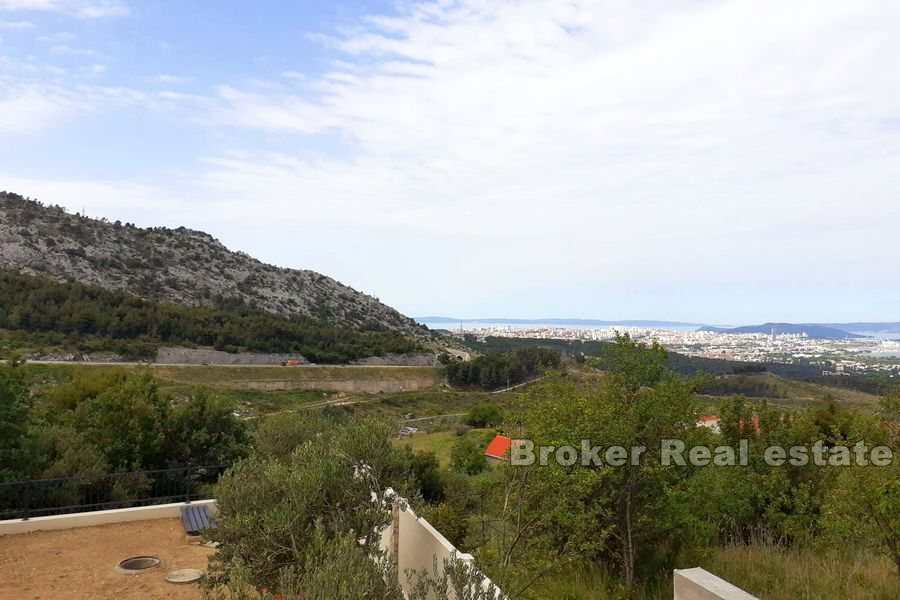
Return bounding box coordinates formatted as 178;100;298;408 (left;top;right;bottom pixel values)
0;269;420;362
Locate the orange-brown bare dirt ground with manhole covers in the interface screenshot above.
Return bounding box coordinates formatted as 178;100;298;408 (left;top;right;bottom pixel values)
0;519;213;600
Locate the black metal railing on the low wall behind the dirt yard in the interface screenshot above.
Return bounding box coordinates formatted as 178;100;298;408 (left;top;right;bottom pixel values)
0;465;231;521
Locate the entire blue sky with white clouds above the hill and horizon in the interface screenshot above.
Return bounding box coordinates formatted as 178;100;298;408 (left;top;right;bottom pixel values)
0;0;900;325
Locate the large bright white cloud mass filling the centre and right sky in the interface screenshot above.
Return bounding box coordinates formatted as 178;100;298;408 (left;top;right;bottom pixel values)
204;0;900;318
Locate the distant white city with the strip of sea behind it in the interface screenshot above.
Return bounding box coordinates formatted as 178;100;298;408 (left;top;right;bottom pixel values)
419;317;900;375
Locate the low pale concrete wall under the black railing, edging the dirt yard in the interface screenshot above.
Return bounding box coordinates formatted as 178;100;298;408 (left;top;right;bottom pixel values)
0;500;216;535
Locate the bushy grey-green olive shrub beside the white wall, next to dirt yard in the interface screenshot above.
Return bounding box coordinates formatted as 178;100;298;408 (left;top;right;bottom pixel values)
210;420;410;587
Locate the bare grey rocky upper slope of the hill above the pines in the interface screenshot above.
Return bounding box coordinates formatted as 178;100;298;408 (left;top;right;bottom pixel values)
0;192;423;335
